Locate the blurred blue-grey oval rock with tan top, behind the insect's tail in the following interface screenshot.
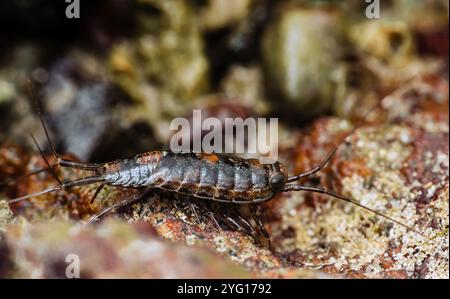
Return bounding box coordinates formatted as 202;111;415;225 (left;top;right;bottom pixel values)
42;50;111;160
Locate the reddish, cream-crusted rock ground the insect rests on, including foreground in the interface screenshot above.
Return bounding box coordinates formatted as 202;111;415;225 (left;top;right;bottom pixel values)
0;77;449;278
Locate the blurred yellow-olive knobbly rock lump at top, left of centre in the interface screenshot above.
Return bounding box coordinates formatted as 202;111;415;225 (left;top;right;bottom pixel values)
110;0;208;102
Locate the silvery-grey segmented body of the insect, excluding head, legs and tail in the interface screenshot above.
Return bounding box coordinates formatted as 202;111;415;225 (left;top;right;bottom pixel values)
103;151;273;201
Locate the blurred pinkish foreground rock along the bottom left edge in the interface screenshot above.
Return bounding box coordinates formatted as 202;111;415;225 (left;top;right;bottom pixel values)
1;220;249;278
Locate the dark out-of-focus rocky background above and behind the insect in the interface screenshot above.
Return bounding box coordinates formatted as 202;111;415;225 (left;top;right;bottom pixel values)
0;0;448;162
